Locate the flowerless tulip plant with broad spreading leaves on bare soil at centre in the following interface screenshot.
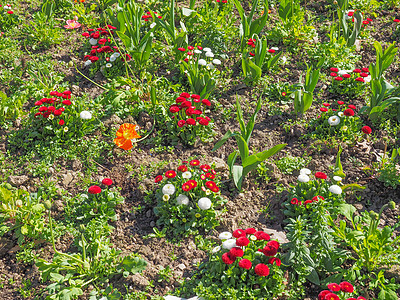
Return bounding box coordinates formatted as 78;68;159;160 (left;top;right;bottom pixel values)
213;98;286;191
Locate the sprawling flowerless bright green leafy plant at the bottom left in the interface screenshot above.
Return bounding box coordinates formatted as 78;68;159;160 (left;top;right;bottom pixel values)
36;227;147;300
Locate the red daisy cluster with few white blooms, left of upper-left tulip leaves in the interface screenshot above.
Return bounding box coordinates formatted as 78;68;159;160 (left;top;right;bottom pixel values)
82;25;131;70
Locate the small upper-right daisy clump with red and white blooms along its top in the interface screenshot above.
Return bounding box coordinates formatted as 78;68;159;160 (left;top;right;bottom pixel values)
329;67;371;97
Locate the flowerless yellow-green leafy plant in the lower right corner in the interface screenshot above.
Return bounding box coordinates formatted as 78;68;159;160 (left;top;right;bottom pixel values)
329;201;400;300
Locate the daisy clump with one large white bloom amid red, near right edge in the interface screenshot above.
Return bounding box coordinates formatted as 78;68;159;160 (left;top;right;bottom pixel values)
311;101;372;141
